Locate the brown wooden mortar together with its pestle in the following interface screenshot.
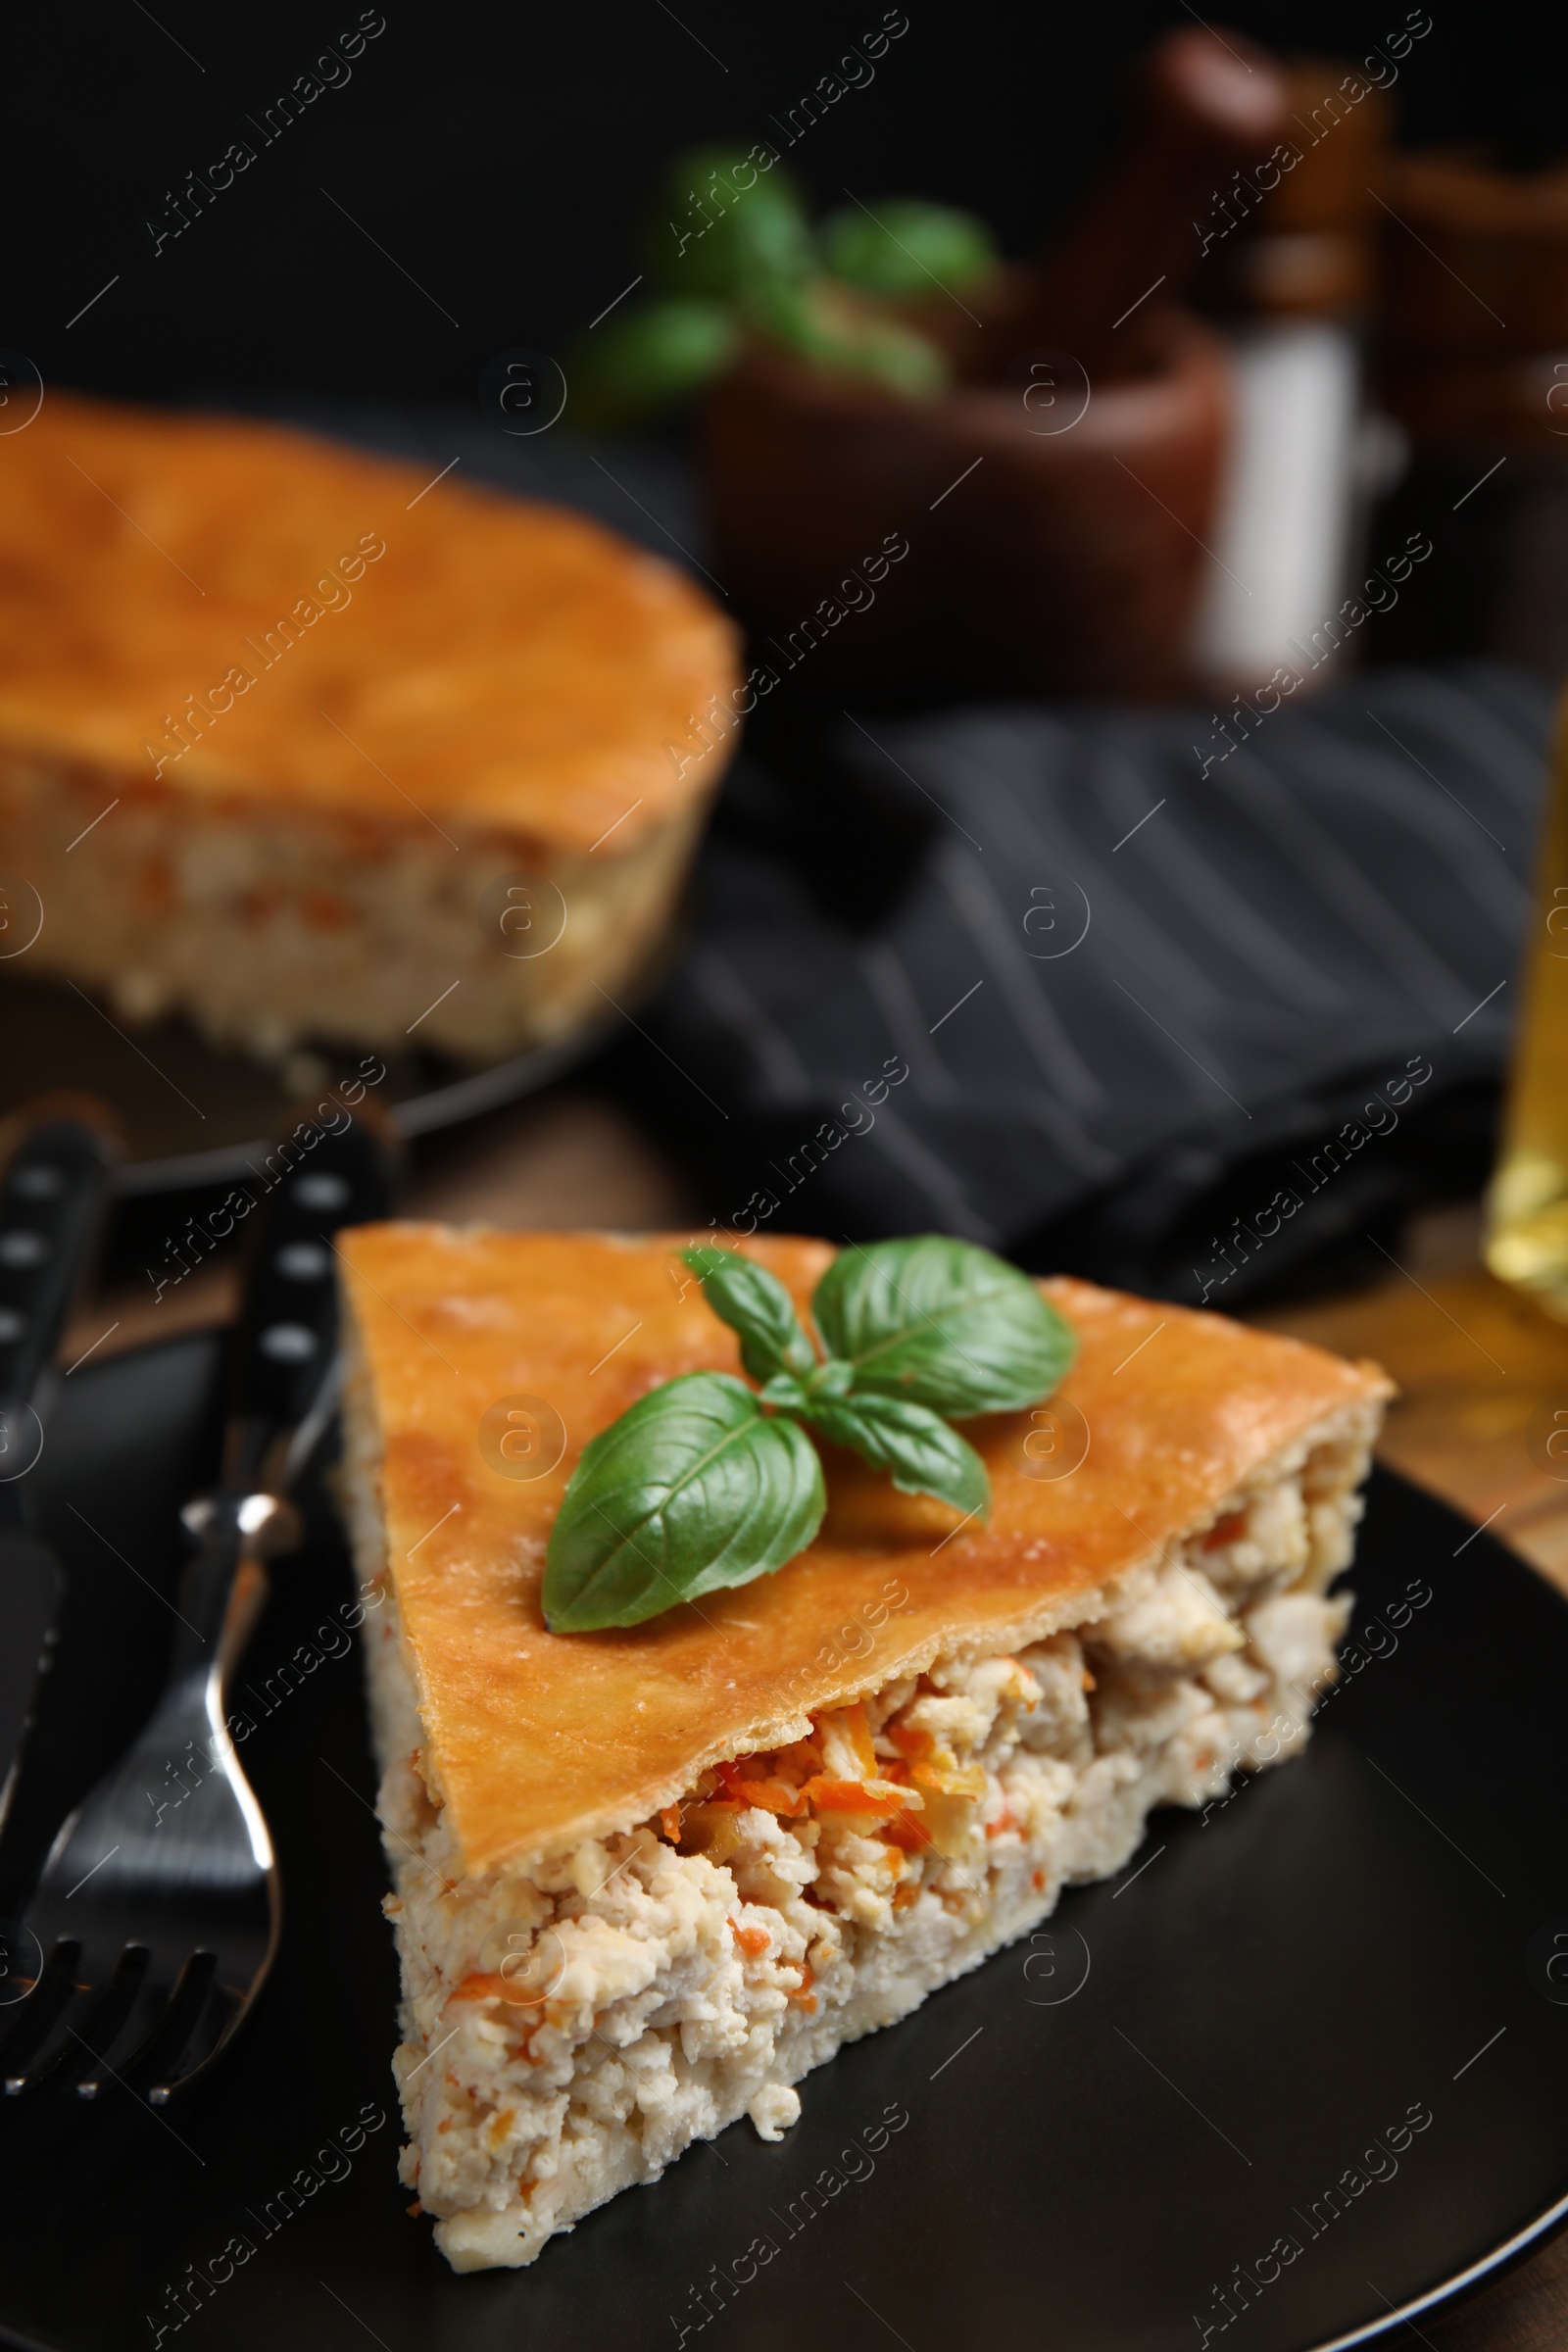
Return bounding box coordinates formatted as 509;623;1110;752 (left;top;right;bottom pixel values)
706;25;1286;699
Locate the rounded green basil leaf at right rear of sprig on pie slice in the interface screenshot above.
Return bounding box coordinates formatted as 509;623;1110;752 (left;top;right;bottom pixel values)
811;1233;1077;1418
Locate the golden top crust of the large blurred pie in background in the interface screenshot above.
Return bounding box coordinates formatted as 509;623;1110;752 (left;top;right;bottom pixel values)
0;390;738;852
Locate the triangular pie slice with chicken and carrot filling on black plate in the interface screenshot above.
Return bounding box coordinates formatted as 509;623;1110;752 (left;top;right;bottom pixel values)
343;1225;1390;2270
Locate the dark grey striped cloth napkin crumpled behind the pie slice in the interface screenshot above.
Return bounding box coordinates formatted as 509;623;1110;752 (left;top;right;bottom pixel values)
639;665;1549;1305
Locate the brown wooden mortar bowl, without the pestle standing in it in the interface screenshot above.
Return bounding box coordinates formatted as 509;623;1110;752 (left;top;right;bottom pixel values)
706;304;1230;696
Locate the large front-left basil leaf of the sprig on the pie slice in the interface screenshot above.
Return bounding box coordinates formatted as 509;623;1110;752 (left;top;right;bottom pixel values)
543;1371;827;1633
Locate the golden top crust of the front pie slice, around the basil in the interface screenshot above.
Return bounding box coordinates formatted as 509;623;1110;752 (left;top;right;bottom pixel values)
341;1223;1392;1872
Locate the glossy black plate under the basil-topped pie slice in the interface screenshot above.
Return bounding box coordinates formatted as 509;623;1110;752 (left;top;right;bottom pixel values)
0;1339;1568;2352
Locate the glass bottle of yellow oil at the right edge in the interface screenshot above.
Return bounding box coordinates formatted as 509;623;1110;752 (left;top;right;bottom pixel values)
1486;699;1568;1322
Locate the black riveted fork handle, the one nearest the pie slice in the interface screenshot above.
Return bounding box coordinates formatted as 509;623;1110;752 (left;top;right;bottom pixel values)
223;1103;400;1489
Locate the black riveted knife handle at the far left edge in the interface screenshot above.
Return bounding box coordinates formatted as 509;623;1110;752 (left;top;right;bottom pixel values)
0;1099;120;1404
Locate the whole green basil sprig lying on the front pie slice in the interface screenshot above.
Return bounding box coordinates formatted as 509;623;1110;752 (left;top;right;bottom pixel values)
543;1235;1077;1633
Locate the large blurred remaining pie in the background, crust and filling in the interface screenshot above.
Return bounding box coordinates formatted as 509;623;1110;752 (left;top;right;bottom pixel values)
0;390;736;1060
